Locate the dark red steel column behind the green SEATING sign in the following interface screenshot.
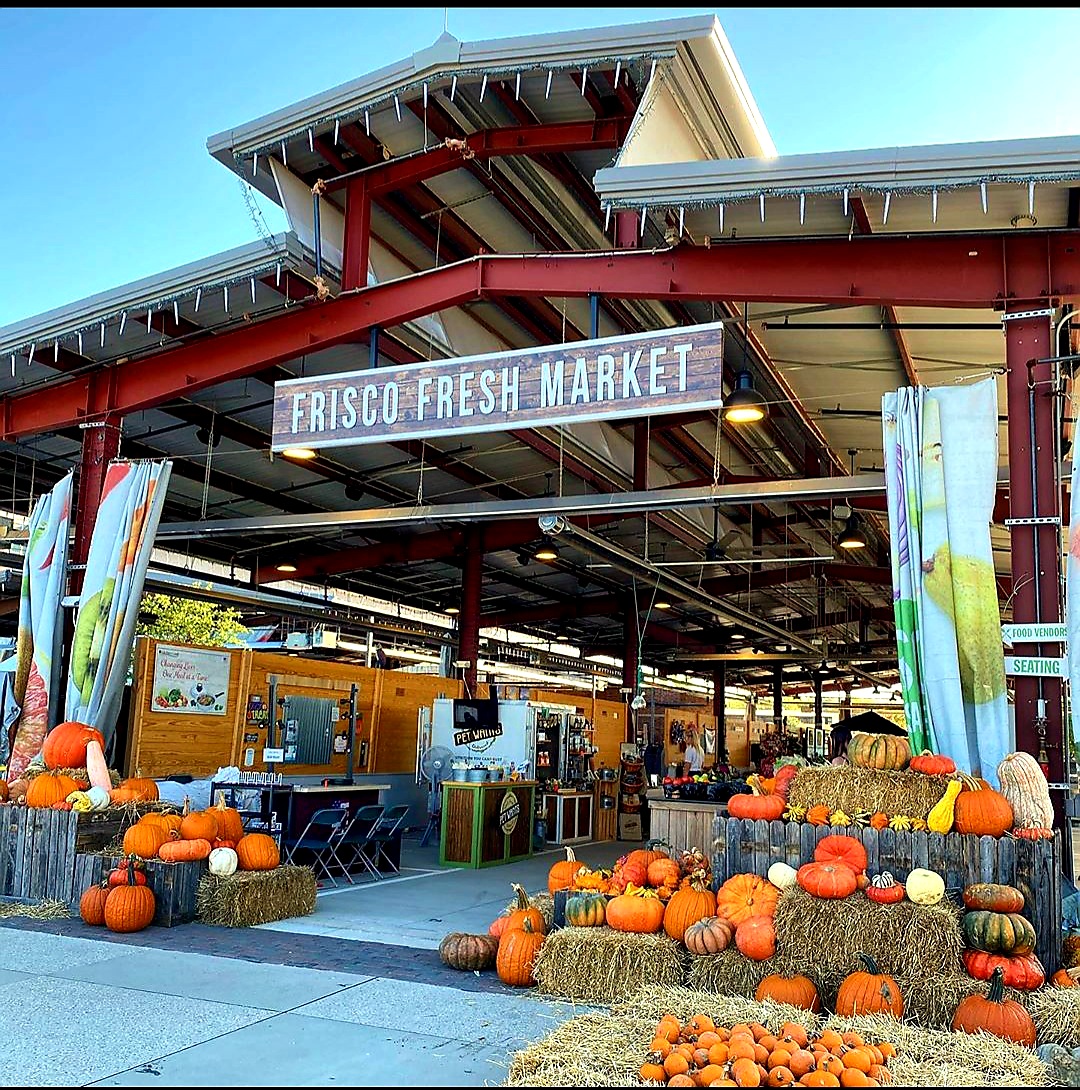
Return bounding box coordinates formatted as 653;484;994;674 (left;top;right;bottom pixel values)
1006;298;1065;826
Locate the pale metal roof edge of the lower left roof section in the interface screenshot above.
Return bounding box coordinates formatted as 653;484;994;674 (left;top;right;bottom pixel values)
0;233;310;355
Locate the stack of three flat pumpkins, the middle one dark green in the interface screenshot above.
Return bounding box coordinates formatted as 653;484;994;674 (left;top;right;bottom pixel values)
961;882;1046;992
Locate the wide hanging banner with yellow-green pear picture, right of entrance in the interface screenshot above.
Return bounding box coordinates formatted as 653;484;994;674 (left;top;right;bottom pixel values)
882;379;1012;782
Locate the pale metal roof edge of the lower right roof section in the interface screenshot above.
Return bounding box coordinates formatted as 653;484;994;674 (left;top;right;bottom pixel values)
594;136;1080;208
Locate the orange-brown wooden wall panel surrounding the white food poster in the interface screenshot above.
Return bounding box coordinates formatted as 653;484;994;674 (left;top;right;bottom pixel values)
123;638;251;779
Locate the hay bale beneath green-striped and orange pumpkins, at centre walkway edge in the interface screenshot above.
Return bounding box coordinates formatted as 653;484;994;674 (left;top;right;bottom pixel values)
533;928;688;1002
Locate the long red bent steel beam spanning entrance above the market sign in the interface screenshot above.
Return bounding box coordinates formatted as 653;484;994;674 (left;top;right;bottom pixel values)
0;231;1080;439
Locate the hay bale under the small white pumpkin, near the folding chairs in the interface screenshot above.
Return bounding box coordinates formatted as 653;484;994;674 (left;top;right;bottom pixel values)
195;864;315;928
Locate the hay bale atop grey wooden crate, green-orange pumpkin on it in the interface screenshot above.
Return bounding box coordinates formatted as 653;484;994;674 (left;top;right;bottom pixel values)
788;765;945;820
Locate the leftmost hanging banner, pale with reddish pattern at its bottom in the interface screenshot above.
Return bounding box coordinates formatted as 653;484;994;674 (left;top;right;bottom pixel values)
0;473;73;783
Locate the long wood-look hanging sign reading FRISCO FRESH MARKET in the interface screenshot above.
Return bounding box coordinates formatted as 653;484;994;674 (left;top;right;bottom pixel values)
272;323;724;450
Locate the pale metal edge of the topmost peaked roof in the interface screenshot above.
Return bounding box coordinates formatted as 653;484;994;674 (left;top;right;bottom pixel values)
206;15;717;165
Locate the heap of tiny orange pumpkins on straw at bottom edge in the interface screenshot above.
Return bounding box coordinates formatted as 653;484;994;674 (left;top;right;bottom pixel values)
638;1014;896;1087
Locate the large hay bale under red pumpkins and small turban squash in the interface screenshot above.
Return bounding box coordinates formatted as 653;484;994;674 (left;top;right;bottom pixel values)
776;887;963;983
